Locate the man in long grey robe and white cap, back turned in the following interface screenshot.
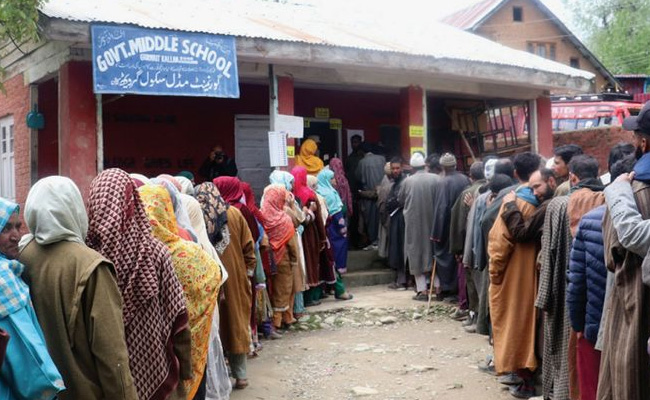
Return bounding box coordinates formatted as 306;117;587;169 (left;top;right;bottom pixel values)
399;152;440;301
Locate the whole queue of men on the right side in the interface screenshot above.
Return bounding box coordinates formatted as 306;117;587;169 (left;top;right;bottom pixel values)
368;104;650;400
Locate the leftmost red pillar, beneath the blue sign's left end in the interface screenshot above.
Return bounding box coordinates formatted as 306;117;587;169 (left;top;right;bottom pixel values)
59;61;97;198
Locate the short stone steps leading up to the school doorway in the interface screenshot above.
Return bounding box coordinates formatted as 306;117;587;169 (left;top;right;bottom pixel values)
343;250;395;288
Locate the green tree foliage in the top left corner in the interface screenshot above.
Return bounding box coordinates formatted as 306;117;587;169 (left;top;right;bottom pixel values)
0;0;45;91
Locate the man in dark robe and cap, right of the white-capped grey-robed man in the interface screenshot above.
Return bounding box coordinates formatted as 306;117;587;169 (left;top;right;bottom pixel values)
431;153;470;306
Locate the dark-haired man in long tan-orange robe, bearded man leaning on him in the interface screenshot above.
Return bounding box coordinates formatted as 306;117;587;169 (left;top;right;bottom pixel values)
488;152;540;397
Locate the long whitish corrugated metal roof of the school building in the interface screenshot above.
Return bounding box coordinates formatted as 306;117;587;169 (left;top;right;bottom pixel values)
41;0;594;79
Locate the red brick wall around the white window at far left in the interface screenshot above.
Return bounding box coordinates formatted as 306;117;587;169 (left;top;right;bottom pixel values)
0;74;31;208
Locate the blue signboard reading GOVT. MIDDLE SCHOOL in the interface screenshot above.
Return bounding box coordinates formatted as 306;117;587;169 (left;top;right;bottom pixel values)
91;25;239;98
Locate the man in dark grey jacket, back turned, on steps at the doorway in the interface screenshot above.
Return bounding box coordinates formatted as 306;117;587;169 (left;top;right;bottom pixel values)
356;143;386;245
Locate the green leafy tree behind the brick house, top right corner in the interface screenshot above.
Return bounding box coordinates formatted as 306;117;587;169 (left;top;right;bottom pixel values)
564;0;650;74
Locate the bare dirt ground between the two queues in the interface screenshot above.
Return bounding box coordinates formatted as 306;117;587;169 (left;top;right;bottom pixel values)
231;286;512;400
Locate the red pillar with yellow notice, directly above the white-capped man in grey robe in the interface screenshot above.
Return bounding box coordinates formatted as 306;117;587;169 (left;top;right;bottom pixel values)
400;86;427;162
